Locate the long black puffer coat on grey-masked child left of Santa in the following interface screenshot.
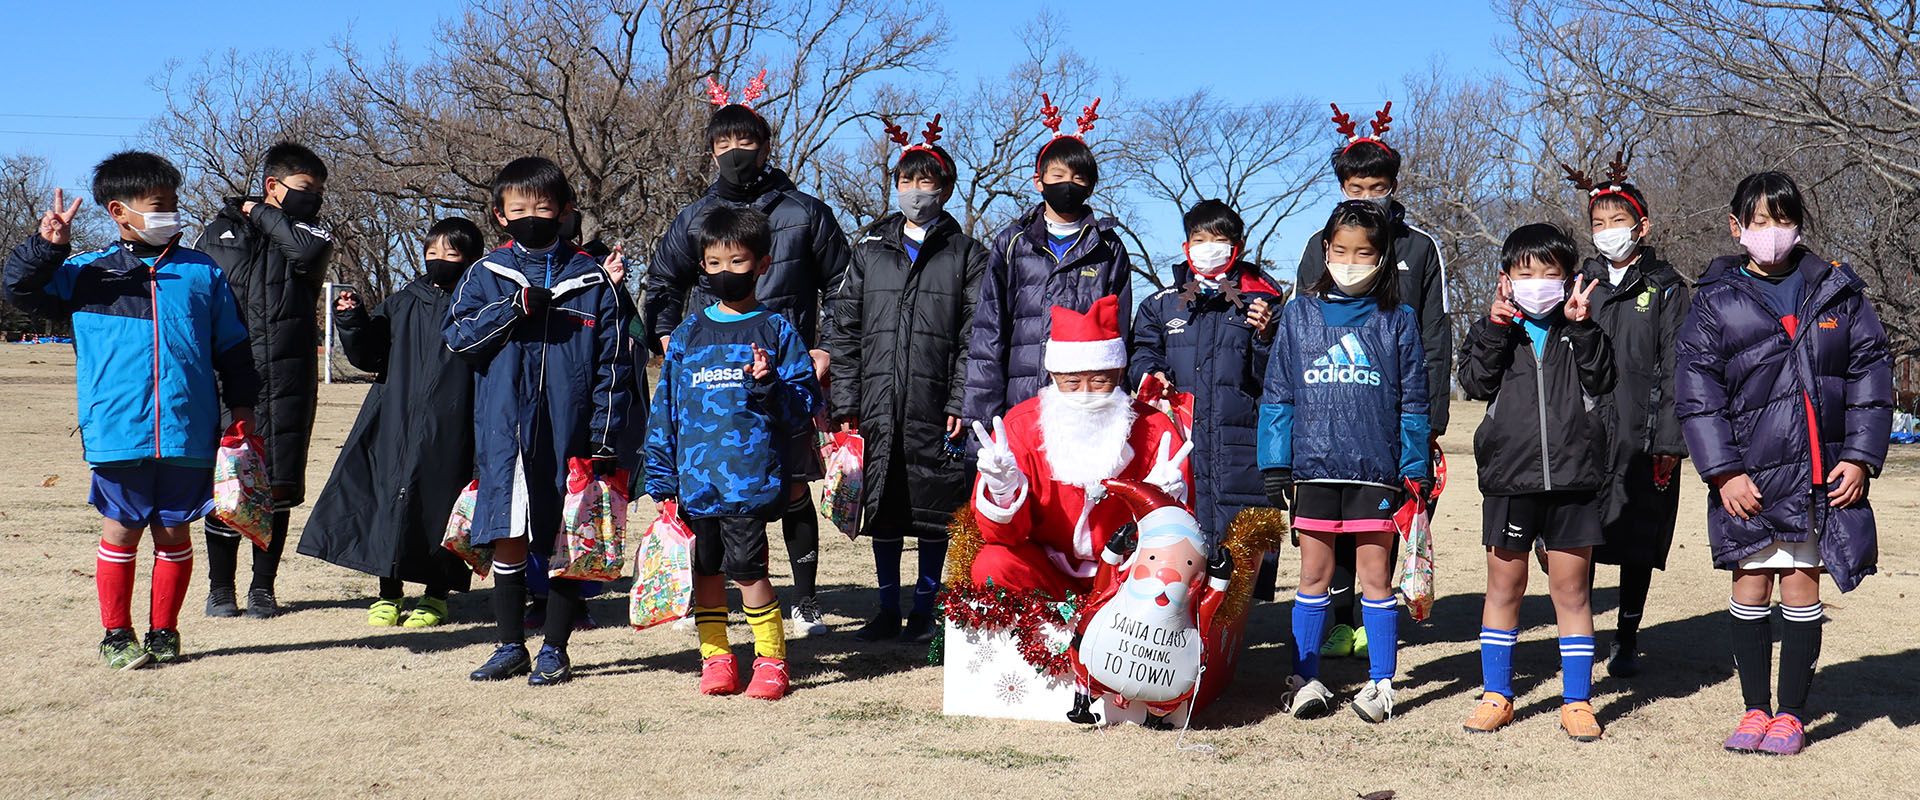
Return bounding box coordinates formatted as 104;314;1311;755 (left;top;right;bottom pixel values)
824;213;987;537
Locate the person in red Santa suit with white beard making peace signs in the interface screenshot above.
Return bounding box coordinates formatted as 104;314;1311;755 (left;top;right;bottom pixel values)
973;295;1192;599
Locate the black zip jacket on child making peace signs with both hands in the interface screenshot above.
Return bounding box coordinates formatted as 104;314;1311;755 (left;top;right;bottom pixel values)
1459;317;1613;497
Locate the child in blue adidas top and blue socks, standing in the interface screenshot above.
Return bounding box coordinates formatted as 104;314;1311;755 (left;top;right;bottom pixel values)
1260;200;1432;721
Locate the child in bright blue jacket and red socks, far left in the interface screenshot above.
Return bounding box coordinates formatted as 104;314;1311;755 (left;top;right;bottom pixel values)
6;152;259;670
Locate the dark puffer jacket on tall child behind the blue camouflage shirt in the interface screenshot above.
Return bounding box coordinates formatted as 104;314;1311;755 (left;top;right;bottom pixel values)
645;169;849;353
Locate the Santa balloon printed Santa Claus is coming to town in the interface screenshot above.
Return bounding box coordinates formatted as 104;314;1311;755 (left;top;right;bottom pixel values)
1068;480;1233;727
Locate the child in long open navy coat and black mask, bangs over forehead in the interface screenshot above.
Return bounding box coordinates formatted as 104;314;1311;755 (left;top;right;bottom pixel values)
442;157;634;687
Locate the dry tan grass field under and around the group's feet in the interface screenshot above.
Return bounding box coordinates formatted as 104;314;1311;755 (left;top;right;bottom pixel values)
0;345;1920;800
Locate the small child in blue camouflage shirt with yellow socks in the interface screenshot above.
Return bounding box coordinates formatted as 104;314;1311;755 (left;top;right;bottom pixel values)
647;207;820;700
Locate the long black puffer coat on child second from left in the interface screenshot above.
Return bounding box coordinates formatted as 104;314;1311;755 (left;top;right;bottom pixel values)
192;198;334;508
